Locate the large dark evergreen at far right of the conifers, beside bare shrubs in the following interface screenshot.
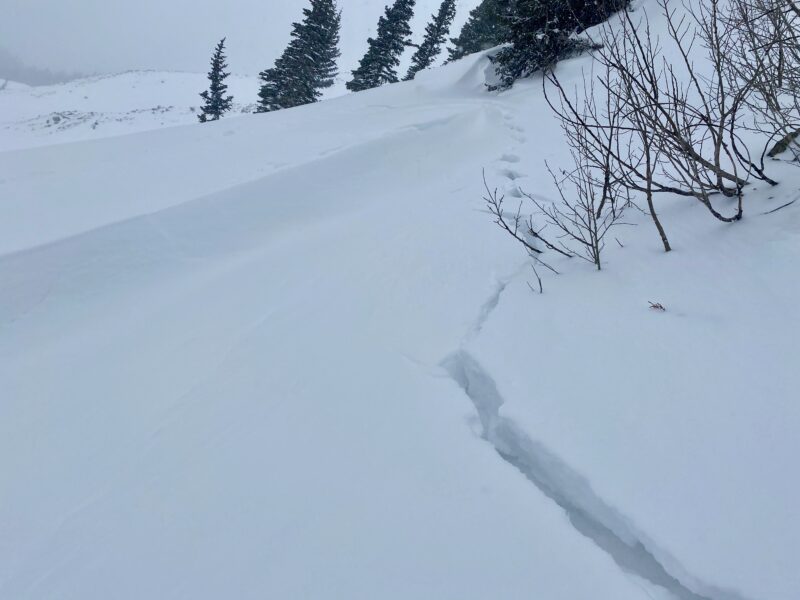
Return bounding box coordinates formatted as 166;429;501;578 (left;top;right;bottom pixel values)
492;0;627;89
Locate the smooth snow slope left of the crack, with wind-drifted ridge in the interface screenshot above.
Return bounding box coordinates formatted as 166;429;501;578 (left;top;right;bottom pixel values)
0;52;646;599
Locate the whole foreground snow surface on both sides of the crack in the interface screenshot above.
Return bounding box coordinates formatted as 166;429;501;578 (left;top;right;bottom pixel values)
0;5;800;600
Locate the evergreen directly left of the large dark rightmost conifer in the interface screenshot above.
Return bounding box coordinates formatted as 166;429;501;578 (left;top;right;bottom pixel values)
447;0;515;62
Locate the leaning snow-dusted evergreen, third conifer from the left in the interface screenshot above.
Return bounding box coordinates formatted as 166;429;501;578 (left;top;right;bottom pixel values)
346;0;415;92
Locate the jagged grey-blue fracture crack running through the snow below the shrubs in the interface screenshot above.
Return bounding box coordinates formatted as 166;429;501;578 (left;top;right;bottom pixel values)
441;350;744;600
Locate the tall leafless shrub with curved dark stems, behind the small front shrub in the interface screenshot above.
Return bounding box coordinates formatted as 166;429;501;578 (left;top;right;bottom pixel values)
545;0;776;239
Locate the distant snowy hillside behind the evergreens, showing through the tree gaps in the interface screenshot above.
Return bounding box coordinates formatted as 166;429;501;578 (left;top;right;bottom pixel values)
0;0;478;151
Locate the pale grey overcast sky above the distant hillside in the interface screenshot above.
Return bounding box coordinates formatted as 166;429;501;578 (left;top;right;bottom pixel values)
0;0;362;73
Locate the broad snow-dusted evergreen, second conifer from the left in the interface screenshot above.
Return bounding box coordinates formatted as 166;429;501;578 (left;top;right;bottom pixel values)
257;0;341;112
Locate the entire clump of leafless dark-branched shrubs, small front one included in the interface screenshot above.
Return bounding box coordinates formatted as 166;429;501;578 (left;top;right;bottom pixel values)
487;0;800;269
